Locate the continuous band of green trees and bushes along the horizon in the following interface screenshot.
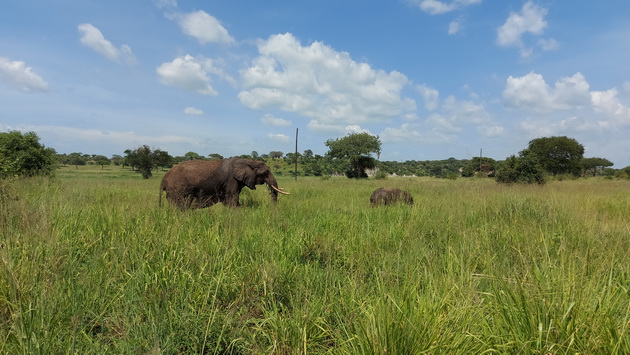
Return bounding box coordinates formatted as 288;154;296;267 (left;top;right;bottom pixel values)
0;131;630;184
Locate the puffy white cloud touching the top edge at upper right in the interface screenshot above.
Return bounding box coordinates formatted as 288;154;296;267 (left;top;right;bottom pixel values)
497;1;558;57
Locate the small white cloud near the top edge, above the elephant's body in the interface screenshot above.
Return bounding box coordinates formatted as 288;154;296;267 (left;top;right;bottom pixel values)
167;10;234;44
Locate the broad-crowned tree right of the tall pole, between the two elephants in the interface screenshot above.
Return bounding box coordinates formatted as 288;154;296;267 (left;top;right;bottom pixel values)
325;133;381;178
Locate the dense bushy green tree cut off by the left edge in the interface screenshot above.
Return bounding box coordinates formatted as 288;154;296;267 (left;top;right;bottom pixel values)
0;131;56;178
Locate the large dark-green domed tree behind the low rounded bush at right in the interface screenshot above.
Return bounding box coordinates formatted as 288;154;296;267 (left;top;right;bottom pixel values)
520;136;584;176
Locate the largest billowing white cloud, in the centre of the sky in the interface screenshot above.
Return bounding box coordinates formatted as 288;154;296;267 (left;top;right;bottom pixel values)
238;33;415;127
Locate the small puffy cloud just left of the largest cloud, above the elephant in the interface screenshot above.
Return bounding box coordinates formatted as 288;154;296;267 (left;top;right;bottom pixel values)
156;55;227;96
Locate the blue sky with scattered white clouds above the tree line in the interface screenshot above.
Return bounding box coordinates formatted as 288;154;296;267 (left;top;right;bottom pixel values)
0;0;630;168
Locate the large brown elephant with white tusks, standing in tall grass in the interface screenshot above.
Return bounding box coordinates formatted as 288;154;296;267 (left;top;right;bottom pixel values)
159;158;289;209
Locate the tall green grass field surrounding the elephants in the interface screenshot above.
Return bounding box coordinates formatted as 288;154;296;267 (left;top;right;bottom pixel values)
0;167;630;354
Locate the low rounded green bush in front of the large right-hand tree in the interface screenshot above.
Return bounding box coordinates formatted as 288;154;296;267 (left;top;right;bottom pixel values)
496;155;546;185
